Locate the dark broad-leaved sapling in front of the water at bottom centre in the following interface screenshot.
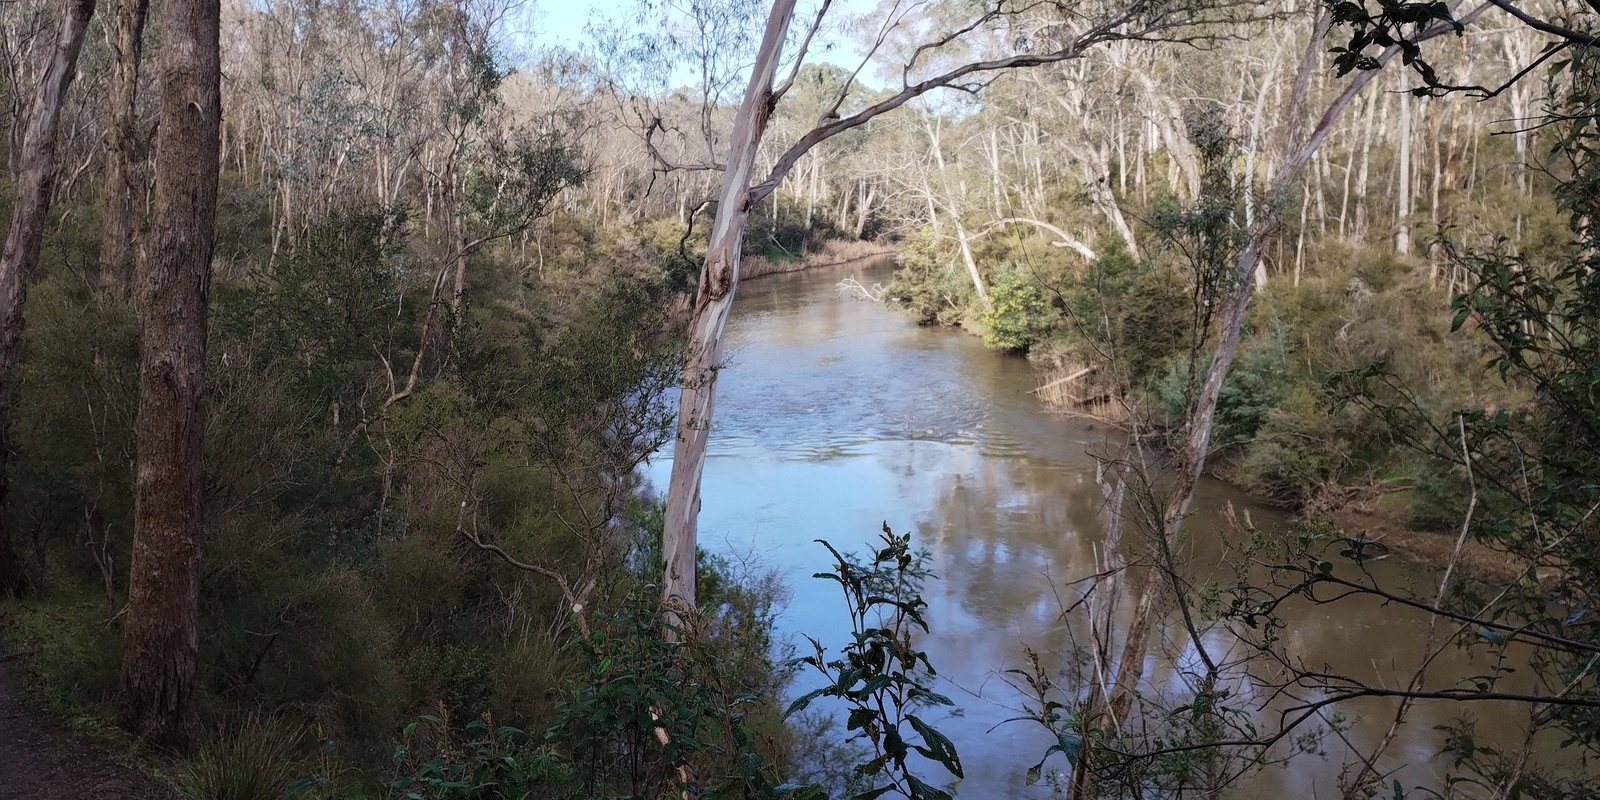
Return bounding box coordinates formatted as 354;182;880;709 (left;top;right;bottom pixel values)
784;523;965;800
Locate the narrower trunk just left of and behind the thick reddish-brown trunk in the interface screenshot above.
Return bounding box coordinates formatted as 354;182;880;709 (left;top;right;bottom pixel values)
101;0;150;293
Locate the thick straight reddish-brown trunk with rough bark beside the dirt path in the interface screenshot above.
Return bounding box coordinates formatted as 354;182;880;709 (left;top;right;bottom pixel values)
118;0;222;752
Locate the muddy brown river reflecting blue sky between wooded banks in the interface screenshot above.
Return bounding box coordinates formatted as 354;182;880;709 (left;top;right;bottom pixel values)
651;262;1526;800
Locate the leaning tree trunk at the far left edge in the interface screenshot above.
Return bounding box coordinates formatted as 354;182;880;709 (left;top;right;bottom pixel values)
0;0;94;594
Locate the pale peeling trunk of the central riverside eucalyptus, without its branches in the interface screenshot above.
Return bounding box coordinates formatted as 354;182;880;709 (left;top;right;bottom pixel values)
661;0;795;610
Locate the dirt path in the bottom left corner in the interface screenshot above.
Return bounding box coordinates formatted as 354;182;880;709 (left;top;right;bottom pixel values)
0;653;160;800
